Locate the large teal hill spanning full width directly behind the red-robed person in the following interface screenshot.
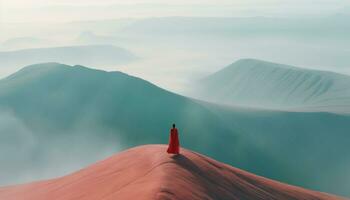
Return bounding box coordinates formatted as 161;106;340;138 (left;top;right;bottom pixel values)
0;63;350;196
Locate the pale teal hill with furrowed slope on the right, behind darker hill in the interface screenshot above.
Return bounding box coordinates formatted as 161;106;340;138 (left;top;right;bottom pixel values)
193;59;350;113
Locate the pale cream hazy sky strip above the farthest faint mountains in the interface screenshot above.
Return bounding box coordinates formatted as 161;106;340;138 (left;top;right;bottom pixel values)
0;0;349;22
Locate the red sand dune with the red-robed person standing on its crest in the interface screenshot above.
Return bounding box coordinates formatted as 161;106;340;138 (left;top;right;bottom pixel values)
0;145;340;200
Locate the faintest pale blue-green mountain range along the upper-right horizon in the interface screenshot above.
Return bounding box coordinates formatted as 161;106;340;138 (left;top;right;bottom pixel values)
120;15;349;39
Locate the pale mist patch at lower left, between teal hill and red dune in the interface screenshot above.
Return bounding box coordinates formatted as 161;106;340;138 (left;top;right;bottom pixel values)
0;109;124;185
